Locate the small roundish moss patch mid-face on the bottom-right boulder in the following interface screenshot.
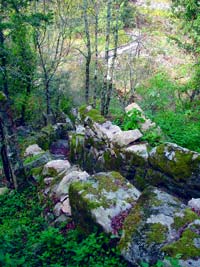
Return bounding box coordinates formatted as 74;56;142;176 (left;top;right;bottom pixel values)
147;223;168;244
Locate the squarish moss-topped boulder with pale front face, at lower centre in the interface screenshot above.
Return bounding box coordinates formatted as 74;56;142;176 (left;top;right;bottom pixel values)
69;172;140;233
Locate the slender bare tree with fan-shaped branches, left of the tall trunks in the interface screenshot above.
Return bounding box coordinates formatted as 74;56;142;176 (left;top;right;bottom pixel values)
34;0;72;123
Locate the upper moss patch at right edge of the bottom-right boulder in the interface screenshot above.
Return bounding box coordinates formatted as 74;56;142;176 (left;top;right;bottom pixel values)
172;209;199;230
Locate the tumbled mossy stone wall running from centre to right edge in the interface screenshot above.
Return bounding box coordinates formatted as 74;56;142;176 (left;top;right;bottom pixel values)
70;108;200;199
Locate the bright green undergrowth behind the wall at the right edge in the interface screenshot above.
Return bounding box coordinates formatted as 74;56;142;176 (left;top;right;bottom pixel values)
139;73;200;151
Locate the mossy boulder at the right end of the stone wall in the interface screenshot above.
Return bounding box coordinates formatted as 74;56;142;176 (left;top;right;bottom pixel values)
149;143;200;198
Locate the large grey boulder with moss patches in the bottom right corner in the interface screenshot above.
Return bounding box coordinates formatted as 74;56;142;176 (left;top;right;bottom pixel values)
119;187;200;266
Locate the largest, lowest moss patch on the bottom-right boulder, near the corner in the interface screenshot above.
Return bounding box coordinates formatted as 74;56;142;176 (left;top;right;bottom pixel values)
162;229;200;260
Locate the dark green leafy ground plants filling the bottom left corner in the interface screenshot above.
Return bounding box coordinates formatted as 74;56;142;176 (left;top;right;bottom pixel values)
0;188;126;267
